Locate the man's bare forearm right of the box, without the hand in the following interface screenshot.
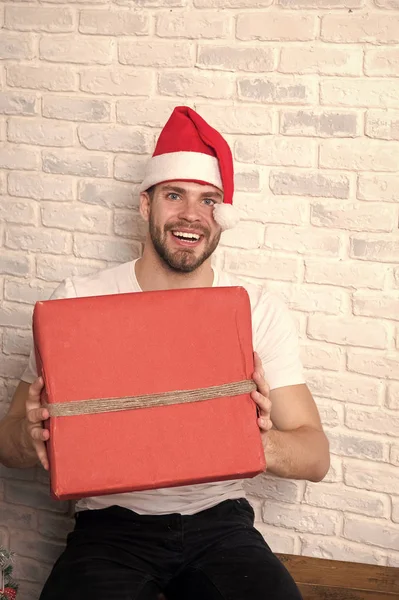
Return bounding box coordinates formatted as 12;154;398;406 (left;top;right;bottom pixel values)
262;427;330;481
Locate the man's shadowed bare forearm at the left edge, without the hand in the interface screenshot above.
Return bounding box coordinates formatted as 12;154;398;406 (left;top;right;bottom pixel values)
0;415;38;469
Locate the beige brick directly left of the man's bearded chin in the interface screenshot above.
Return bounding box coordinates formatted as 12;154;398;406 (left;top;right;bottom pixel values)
73;233;141;262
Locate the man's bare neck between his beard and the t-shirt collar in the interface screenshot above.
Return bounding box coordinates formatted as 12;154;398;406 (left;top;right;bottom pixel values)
135;251;214;292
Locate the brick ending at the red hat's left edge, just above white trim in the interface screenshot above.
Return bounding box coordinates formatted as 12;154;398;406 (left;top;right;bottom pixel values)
78;124;152;154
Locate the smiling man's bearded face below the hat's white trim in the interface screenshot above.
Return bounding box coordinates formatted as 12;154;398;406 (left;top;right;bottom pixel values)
141;181;223;273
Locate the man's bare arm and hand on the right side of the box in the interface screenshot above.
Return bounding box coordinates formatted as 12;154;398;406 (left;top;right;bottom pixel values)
252;355;330;481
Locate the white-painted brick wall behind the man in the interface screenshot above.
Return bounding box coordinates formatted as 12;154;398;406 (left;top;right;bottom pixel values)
0;0;399;600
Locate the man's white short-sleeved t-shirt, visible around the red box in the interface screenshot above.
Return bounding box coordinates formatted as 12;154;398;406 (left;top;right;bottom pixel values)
22;261;305;515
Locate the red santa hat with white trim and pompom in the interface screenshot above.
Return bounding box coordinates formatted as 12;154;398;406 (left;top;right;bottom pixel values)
140;106;239;230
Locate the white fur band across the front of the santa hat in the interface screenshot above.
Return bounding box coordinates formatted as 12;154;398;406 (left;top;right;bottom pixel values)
140;152;223;192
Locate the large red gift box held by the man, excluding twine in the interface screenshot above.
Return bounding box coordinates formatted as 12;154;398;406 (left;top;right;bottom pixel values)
33;287;265;499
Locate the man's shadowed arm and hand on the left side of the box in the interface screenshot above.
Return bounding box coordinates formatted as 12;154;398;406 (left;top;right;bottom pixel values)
0;378;49;469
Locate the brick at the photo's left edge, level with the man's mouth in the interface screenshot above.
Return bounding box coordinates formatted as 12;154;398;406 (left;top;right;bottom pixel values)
5;226;71;254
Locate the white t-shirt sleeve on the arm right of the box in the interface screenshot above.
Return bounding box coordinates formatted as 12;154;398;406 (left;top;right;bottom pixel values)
252;292;305;389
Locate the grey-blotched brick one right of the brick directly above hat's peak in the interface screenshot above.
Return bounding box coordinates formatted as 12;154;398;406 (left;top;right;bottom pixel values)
237;75;318;104
